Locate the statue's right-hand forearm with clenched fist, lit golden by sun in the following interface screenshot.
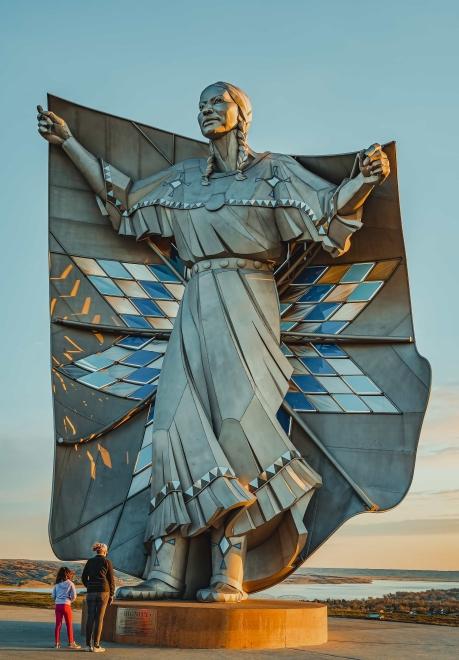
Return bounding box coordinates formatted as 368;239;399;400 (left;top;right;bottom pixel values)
337;144;390;215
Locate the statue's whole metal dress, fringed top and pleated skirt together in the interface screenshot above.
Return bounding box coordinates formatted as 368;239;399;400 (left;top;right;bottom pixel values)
98;154;360;584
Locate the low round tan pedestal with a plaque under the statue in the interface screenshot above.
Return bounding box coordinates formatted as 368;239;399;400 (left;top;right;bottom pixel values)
98;599;327;649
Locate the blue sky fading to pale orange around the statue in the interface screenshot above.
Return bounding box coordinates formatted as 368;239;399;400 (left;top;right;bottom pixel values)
0;0;459;568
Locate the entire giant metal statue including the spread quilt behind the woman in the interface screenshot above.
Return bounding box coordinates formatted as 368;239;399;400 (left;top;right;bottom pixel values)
38;82;430;602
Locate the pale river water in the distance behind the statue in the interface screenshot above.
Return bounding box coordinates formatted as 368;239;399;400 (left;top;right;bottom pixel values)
0;580;459;600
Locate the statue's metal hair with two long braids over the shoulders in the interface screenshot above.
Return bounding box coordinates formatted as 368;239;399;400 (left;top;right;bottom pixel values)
201;81;252;186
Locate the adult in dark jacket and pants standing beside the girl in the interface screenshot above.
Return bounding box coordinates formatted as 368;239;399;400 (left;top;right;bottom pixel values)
81;542;115;653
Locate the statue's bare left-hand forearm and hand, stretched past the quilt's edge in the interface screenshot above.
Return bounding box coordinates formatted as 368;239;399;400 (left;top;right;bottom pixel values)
37;105;105;201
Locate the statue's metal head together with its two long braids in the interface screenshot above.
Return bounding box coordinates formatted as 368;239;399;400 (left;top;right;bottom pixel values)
198;81;252;185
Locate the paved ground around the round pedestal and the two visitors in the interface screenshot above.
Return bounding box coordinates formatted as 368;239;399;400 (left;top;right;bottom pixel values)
0;605;459;660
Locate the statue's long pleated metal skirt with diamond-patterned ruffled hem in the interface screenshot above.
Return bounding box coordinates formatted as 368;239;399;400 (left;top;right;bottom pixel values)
145;260;320;542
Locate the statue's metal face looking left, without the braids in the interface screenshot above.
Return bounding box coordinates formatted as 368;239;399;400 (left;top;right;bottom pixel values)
198;85;239;140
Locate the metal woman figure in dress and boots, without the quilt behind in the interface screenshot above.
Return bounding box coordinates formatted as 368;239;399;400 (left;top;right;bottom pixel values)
38;82;430;602
